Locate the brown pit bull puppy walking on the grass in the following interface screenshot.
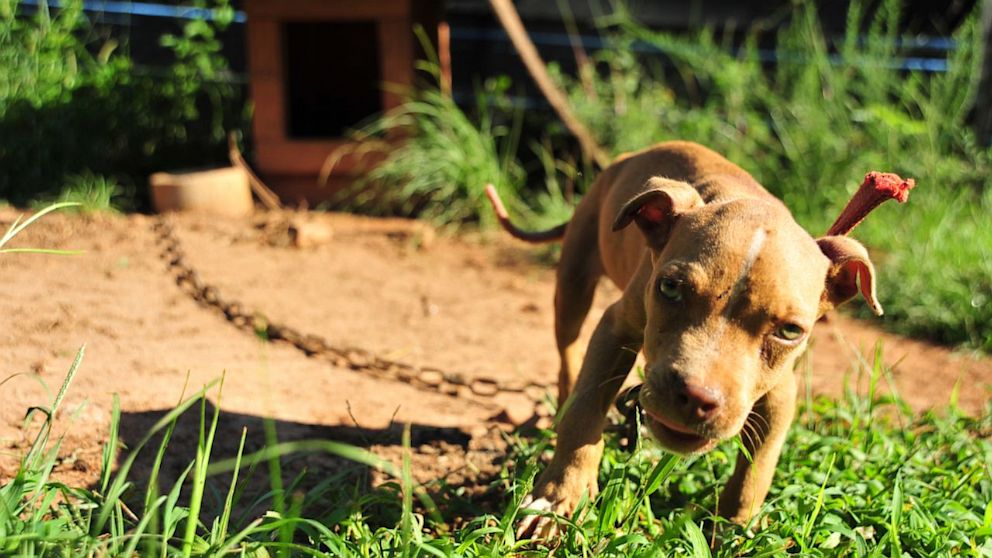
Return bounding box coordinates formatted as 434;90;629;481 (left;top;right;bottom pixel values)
490;142;882;537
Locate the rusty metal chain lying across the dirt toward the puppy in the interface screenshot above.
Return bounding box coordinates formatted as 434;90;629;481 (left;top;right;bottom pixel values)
152;216;552;414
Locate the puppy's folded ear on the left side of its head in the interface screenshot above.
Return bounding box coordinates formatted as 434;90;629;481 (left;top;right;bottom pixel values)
613;176;704;250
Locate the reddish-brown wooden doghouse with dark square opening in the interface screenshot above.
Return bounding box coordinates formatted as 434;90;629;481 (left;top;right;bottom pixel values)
245;0;441;204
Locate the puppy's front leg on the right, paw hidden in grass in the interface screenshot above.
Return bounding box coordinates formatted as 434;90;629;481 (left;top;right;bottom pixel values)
719;373;796;524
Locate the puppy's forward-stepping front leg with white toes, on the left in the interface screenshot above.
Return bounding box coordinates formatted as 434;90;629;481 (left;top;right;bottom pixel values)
517;300;643;538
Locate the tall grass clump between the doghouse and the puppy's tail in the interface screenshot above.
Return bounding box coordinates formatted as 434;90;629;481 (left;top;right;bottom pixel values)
330;29;587;234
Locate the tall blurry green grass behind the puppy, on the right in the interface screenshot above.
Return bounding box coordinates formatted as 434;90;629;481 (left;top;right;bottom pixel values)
560;0;992;351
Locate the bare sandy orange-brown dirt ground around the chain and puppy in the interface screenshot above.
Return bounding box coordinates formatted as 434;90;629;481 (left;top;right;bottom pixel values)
0;209;992;498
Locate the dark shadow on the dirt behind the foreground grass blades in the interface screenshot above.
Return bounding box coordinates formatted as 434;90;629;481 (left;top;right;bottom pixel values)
102;402;506;525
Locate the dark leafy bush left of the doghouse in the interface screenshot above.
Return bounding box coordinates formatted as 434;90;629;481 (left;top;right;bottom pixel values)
0;0;244;206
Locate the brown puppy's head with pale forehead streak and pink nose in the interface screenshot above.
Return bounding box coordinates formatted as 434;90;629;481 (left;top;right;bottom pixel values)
613;178;882;453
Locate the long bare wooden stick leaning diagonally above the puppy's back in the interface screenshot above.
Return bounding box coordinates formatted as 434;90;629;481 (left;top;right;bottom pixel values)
489;0;610;167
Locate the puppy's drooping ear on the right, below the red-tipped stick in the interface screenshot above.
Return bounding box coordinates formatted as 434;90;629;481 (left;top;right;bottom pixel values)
816;236;883;316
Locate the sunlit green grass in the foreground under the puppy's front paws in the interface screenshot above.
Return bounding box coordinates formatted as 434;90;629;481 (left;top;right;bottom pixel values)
0;350;992;556
